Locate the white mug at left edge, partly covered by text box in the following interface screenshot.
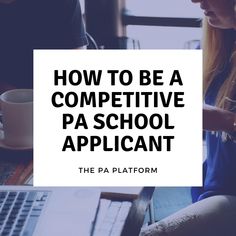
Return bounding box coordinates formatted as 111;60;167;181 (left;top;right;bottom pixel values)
0;89;33;148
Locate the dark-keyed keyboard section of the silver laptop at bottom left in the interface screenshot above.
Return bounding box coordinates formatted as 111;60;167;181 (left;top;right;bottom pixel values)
0;191;49;236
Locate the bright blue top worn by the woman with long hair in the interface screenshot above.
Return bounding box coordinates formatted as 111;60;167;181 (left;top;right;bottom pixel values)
200;63;236;196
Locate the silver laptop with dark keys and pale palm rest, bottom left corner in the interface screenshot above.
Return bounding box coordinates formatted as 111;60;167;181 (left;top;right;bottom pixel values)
0;186;100;236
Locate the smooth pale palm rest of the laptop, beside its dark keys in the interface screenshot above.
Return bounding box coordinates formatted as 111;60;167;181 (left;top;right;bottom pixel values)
35;188;100;236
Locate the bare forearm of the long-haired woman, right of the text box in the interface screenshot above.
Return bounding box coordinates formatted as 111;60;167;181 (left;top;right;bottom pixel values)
203;105;236;132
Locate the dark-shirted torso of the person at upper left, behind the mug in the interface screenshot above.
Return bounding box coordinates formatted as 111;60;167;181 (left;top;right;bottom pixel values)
0;0;82;88
